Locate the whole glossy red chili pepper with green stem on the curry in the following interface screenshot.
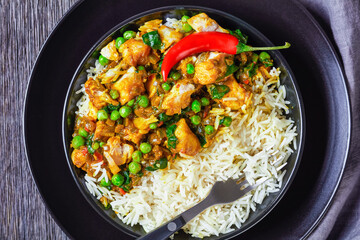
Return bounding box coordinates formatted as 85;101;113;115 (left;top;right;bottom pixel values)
161;32;290;82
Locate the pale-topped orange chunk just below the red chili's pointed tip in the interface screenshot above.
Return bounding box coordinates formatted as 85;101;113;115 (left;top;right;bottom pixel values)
161;80;195;115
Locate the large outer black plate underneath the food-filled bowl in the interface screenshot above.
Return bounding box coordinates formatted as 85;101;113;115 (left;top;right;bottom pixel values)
24;0;350;239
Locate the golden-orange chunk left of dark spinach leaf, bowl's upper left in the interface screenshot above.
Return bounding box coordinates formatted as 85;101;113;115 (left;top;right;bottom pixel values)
119;38;151;67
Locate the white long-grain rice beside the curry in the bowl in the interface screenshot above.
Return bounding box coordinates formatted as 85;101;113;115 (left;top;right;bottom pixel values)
77;62;297;238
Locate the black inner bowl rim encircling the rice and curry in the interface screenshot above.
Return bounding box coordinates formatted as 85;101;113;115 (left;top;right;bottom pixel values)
62;6;305;240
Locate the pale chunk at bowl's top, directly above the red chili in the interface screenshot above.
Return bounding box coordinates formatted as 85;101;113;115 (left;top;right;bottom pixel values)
188;13;228;33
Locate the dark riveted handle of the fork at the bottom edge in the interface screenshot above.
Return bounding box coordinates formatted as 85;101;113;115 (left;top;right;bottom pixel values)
138;215;186;240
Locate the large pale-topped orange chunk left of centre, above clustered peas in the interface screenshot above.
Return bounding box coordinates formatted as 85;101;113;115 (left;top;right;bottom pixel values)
111;67;145;105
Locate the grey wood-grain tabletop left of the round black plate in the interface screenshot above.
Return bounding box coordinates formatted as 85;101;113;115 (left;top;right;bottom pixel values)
0;0;76;239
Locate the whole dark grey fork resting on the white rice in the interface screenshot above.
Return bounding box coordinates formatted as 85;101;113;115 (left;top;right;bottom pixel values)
138;176;268;240
